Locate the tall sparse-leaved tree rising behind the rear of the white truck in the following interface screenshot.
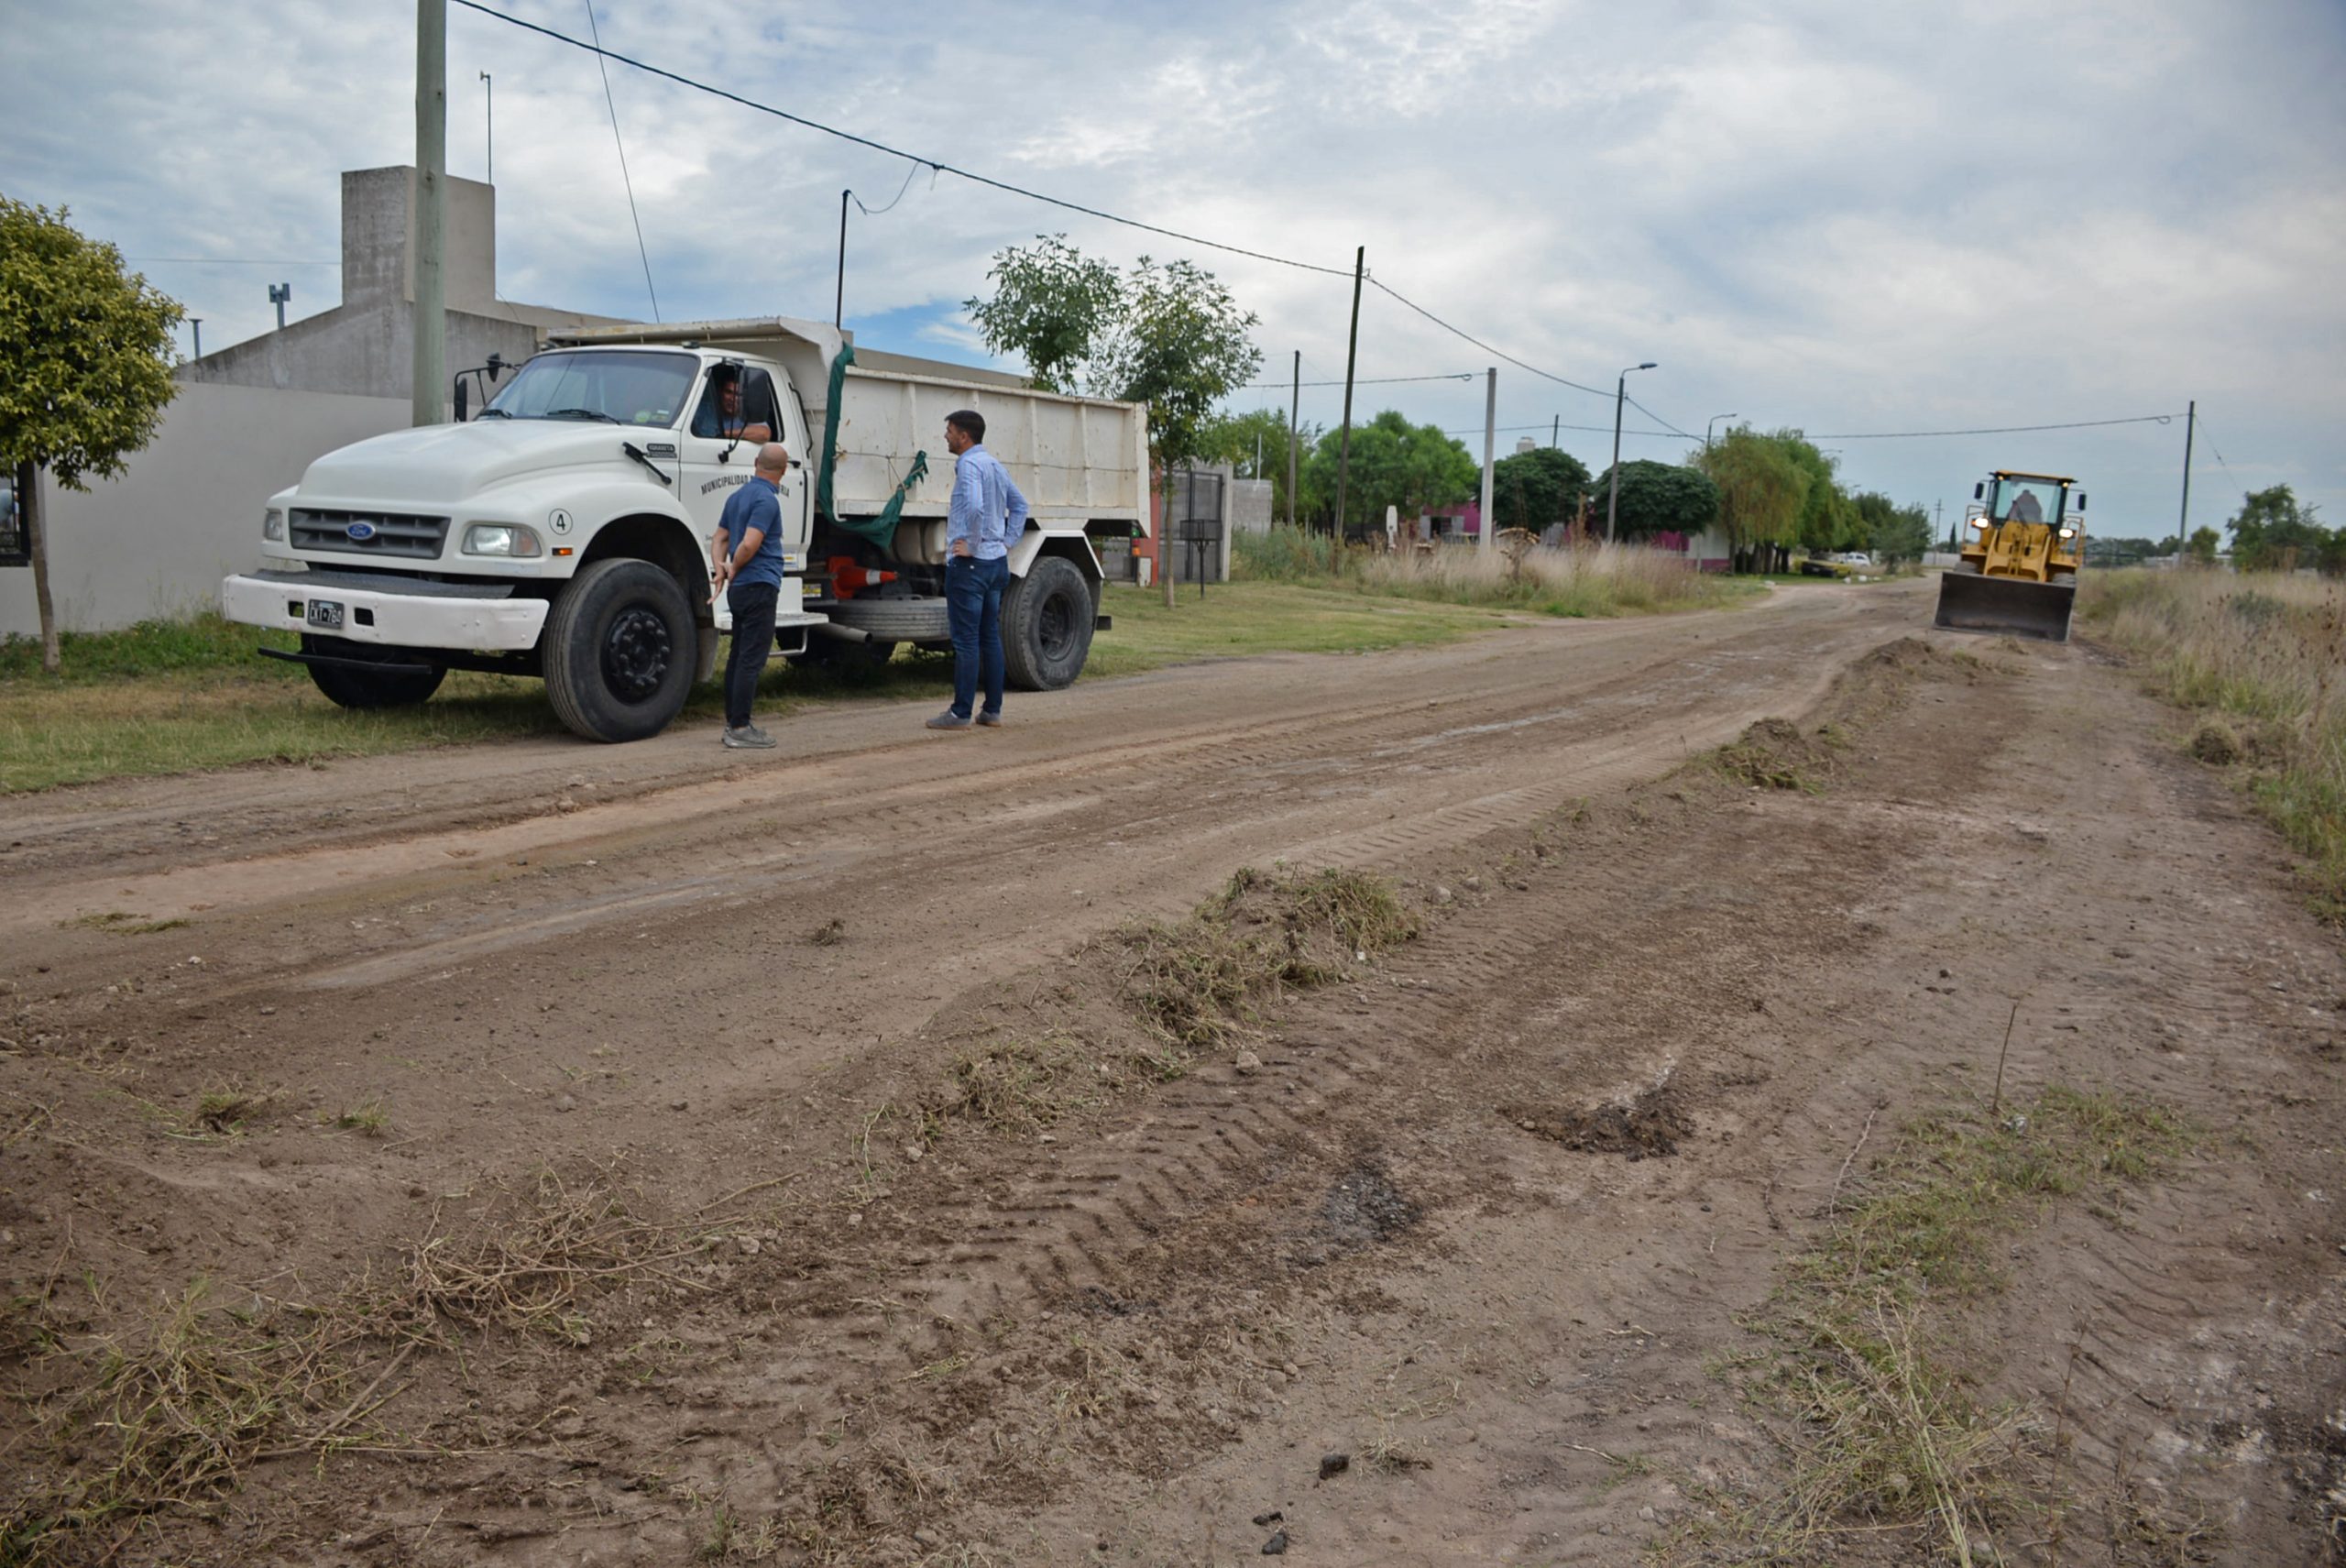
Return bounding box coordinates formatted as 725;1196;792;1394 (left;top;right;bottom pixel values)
967;235;1262;606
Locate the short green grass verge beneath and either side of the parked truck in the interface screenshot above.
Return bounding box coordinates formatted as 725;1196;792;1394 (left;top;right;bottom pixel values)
0;582;1508;794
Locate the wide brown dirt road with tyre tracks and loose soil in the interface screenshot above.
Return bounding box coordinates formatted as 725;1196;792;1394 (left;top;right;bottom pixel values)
0;587;2346;1563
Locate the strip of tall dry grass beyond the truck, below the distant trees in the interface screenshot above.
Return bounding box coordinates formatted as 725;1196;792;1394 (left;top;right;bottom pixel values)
1232;528;1752;615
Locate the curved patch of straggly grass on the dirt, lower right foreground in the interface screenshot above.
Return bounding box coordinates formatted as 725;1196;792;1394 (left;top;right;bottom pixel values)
1656;1087;2194;1565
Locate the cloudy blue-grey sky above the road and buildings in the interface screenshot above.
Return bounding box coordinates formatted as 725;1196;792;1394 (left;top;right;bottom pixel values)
0;0;2346;535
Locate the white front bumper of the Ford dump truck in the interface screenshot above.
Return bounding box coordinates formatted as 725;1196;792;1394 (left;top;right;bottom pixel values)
221;573;549;652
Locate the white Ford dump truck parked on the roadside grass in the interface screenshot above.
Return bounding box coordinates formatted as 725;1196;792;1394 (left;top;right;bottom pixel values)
221;317;1149;741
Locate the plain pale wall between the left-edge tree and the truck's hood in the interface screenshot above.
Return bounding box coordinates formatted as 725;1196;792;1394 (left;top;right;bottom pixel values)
0;383;408;636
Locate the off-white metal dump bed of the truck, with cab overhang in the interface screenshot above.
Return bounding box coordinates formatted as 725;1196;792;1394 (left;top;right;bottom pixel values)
539;317;1149;528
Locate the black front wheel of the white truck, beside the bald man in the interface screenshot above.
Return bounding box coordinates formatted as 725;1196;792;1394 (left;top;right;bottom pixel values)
540;559;699;741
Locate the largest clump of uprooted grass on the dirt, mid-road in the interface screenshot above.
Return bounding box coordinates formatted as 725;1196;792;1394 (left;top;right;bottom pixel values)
1124;866;1417;1049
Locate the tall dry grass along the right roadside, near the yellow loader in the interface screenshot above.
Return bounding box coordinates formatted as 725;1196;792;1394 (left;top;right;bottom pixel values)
2078;568;2346;920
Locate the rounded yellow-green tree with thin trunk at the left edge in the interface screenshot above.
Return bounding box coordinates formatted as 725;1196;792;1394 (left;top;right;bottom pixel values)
0;197;185;674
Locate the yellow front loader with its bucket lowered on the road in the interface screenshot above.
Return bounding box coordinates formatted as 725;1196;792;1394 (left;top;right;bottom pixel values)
1938;469;2086;643
